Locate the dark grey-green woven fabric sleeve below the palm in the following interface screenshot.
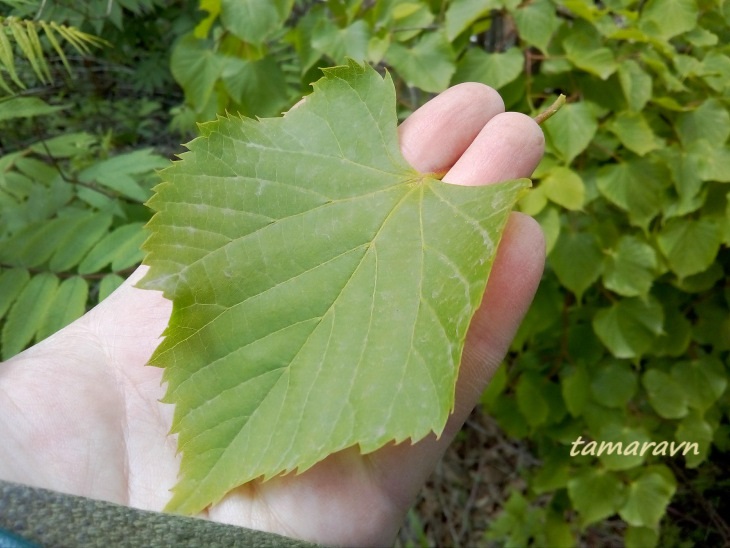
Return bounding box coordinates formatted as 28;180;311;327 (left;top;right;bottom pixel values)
0;481;316;548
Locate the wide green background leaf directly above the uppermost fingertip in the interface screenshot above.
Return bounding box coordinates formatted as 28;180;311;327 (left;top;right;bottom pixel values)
453;48;525;89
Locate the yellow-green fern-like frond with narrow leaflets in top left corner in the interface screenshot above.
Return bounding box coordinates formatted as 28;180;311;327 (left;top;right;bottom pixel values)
0;16;108;93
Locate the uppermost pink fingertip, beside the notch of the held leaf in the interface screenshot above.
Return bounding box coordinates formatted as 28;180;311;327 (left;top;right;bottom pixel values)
398;82;504;173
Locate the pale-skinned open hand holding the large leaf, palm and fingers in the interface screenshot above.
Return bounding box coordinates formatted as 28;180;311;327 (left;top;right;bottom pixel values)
0;83;545;546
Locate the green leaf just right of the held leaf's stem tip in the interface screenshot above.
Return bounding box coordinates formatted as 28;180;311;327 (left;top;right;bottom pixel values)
543;102;598;164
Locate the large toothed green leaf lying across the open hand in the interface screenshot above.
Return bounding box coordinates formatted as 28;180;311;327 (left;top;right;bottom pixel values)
140;61;529;514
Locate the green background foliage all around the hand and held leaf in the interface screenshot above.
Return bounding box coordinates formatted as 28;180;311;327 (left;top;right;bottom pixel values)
0;0;730;546
